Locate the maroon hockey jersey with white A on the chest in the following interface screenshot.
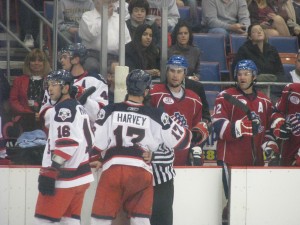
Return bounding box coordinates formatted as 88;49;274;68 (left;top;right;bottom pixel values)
213;88;272;166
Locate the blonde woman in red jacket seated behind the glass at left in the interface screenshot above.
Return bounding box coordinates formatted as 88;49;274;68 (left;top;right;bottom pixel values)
9;49;51;131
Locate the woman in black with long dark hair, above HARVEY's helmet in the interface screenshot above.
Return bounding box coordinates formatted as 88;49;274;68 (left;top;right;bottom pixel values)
125;24;160;78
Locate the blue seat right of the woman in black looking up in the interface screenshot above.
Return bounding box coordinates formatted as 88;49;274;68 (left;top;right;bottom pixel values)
268;36;299;53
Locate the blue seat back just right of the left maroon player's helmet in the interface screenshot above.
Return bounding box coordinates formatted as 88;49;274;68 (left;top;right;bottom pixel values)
199;61;221;91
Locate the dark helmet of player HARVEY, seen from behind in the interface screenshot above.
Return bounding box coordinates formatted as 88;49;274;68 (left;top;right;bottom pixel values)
126;69;152;96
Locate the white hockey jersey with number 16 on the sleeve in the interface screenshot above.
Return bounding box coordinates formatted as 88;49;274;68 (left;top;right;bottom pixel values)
42;99;94;188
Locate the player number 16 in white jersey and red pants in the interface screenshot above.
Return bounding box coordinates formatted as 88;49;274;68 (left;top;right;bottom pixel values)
35;70;94;225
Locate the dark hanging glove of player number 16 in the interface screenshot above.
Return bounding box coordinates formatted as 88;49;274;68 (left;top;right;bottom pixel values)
38;167;59;195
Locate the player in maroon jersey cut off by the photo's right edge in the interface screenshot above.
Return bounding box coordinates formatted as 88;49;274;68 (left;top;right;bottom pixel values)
271;83;300;166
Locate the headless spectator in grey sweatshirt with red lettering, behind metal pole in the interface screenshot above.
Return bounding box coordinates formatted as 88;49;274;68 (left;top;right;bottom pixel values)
147;0;180;32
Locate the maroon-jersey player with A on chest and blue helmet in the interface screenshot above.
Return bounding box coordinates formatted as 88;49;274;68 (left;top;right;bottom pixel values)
212;60;278;223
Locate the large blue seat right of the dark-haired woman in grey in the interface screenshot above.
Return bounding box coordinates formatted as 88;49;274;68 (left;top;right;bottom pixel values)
193;33;229;77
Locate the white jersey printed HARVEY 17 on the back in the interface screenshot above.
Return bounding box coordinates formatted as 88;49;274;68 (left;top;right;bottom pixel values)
95;101;191;172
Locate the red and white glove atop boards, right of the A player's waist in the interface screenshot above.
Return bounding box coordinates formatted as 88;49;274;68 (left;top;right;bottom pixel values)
261;141;280;166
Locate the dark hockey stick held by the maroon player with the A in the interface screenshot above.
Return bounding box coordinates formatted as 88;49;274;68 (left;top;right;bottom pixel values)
223;93;257;166
